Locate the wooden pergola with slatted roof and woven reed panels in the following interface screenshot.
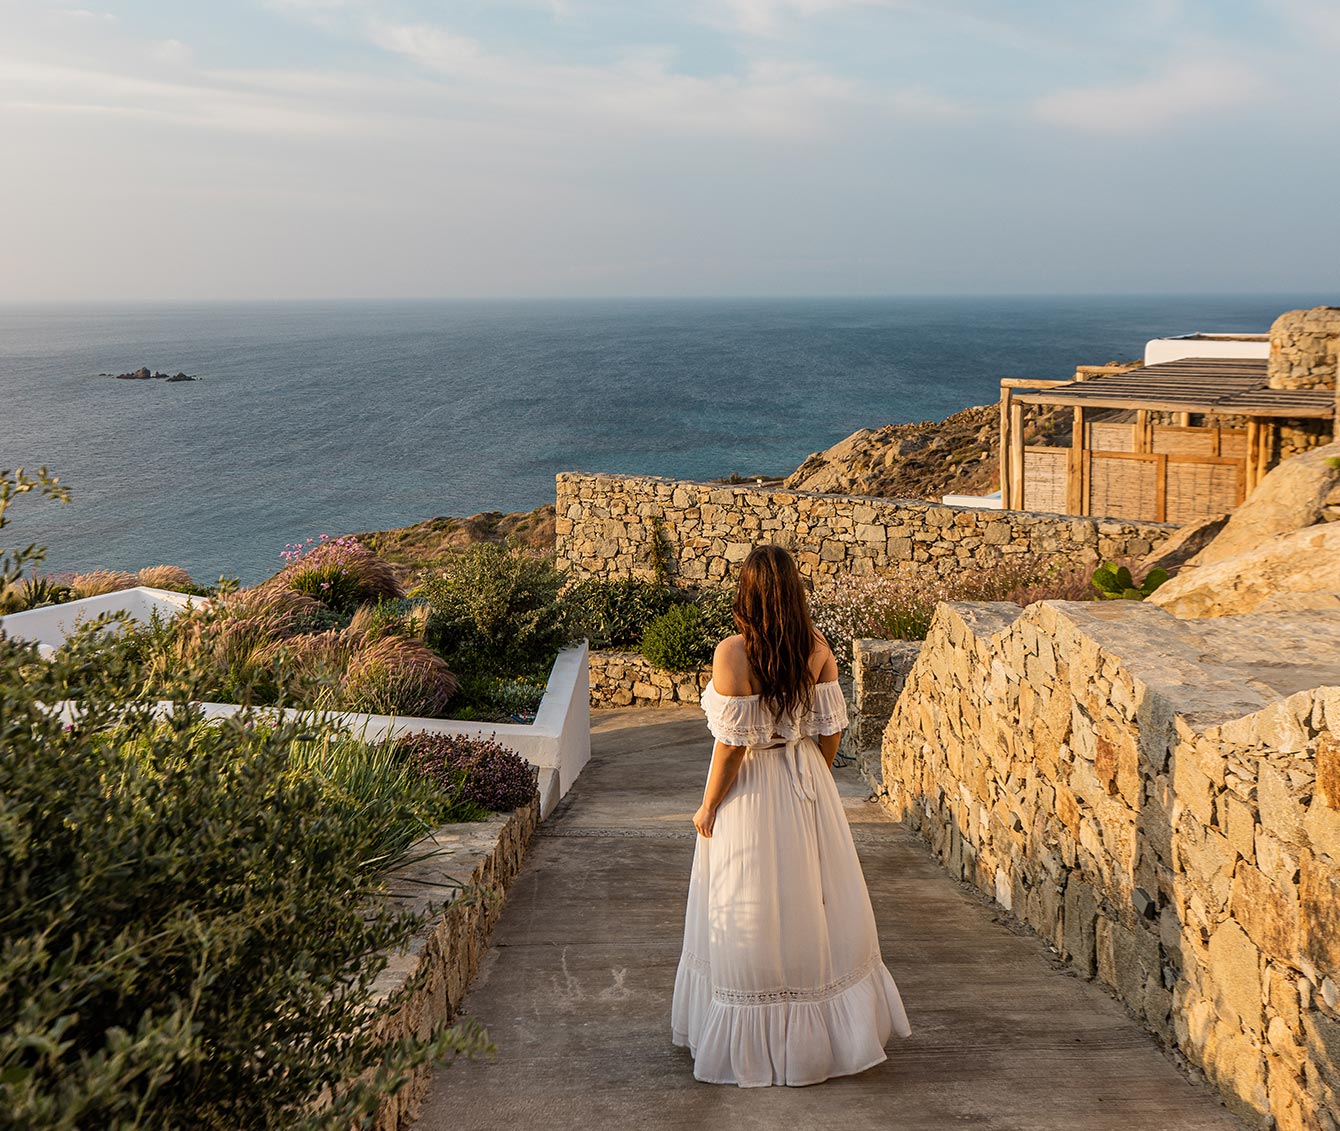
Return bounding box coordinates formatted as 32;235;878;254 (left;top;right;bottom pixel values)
1001;358;1336;523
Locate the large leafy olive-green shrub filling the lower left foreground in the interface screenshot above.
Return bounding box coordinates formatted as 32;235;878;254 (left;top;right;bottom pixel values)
0;628;482;1131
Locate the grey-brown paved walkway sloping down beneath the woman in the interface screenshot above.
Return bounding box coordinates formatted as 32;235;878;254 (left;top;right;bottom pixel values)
418;710;1244;1131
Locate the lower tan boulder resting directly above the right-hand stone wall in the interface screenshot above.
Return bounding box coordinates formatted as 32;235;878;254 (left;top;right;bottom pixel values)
1148;523;1340;618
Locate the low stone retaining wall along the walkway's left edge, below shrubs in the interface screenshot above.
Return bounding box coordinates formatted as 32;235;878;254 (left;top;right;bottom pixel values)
374;799;540;1131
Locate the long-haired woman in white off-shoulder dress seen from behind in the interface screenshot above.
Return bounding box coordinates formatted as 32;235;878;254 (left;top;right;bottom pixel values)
671;545;911;1088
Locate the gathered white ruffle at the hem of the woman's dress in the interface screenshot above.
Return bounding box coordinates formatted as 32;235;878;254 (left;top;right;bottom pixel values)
671;958;911;1088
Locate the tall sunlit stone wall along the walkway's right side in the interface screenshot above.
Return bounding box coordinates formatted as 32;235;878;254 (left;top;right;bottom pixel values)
883;602;1340;1131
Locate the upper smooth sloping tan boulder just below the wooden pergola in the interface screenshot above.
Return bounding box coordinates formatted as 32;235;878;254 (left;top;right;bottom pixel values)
1190;444;1340;566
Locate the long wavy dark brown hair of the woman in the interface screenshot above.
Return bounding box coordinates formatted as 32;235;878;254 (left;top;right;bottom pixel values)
733;545;815;718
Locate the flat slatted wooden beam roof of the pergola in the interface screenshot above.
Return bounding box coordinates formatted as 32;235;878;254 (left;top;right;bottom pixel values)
1014;358;1336;419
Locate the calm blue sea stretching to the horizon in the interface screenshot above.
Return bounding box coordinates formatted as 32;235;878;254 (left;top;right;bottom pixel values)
0;295;1333;582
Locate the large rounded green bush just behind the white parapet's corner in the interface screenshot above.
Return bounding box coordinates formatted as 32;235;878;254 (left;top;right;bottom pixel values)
418;543;572;678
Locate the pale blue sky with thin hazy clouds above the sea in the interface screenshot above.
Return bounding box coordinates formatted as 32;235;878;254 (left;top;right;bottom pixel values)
0;0;1340;302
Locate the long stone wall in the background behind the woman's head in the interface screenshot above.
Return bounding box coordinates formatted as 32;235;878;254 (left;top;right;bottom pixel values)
556;472;1177;584
